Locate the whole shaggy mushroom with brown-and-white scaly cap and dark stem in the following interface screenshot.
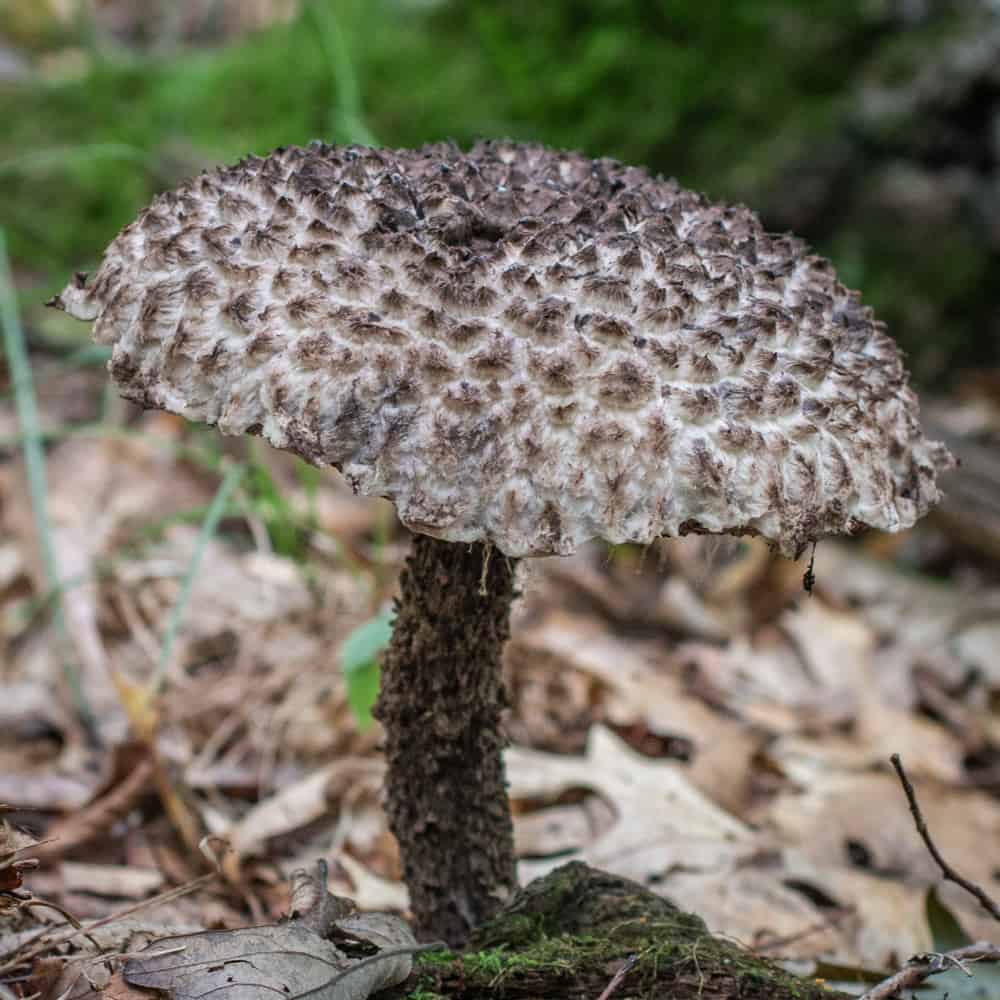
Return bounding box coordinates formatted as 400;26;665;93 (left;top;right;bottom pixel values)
54;142;950;942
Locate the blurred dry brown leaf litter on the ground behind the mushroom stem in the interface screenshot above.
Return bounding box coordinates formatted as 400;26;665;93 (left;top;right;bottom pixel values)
0;360;1000;997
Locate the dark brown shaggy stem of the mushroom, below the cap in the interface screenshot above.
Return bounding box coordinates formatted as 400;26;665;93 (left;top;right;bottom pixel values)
375;535;516;945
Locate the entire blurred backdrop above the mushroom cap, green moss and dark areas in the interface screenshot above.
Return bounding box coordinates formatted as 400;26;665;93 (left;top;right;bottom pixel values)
0;0;1000;388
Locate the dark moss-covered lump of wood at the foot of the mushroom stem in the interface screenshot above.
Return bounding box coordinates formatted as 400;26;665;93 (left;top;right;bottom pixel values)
394;862;847;1000
